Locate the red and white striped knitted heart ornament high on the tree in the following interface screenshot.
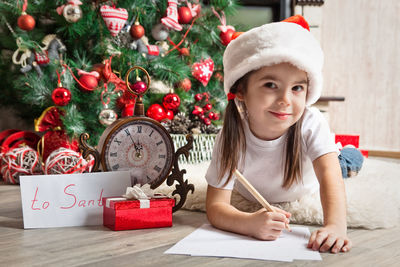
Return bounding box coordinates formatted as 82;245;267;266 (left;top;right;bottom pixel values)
100;5;128;36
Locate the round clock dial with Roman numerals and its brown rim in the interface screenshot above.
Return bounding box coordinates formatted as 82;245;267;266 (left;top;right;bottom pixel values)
102;117;174;188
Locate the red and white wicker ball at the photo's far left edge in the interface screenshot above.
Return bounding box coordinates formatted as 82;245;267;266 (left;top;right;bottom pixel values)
0;146;42;184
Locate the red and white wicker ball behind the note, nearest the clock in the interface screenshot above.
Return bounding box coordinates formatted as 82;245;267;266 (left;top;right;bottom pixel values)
44;147;94;174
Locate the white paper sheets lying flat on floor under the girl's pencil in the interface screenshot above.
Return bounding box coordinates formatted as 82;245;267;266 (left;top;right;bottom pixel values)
164;224;321;262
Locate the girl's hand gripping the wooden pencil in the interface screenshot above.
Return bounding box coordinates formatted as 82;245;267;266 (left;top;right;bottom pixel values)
249;209;290;240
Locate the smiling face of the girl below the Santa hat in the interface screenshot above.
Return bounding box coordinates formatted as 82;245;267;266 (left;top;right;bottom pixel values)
237;63;308;140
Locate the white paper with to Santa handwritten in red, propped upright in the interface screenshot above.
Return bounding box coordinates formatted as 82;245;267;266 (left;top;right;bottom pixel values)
20;171;131;229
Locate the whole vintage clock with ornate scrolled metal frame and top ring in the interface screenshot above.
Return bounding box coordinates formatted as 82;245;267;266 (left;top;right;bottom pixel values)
80;66;194;211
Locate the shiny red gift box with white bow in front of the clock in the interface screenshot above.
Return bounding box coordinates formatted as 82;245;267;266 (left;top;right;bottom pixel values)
103;197;175;231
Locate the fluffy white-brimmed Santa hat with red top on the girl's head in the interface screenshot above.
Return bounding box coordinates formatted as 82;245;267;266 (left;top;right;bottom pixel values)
223;15;324;105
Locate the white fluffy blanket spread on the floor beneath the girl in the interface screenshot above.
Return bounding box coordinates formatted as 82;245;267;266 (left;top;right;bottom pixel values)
157;159;400;229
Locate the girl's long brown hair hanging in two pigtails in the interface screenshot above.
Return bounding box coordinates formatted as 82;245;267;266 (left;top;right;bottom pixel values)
218;72;304;189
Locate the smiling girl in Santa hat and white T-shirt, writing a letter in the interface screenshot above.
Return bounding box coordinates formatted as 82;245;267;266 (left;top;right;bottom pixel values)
206;16;358;253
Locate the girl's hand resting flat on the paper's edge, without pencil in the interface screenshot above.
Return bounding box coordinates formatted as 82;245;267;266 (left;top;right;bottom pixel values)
307;225;352;253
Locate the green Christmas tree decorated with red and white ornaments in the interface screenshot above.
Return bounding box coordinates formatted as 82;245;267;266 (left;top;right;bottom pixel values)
0;0;244;151
